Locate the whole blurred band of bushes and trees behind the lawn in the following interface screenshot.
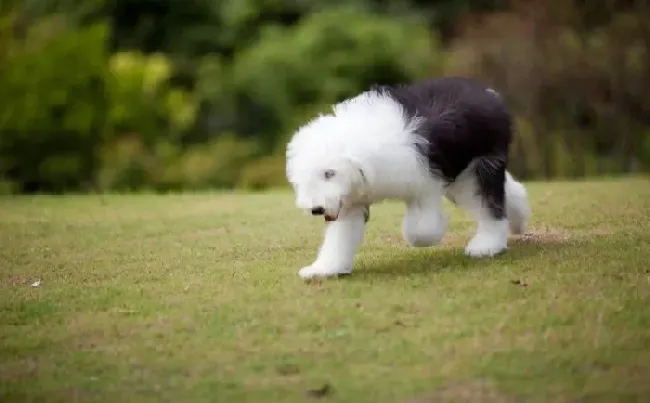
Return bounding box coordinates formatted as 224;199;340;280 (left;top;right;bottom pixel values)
0;0;650;193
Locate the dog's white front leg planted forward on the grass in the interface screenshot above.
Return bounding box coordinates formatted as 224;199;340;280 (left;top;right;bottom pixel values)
298;206;369;279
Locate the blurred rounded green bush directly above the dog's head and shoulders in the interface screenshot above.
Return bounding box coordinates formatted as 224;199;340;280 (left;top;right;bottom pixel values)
227;9;442;151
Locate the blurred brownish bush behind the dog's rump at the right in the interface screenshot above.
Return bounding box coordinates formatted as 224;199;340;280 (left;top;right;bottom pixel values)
451;4;650;178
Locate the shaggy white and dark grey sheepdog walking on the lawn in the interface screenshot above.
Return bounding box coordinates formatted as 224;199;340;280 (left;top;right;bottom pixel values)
286;77;530;279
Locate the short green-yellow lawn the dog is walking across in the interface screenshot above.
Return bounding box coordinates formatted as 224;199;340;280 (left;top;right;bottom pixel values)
0;178;650;403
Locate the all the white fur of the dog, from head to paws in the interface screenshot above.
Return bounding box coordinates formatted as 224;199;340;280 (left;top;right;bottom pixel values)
287;92;530;278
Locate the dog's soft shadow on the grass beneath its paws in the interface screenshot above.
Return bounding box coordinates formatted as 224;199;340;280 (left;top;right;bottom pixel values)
344;233;585;281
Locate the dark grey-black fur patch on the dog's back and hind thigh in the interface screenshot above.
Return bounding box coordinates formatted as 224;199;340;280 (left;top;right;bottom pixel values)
371;77;512;219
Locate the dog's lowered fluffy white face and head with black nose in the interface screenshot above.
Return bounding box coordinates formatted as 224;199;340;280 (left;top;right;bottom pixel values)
287;117;365;221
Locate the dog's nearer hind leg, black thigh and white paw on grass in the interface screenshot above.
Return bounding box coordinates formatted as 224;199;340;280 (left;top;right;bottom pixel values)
448;156;509;257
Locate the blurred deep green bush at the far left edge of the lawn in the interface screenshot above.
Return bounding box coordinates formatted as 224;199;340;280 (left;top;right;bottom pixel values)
0;14;108;191
